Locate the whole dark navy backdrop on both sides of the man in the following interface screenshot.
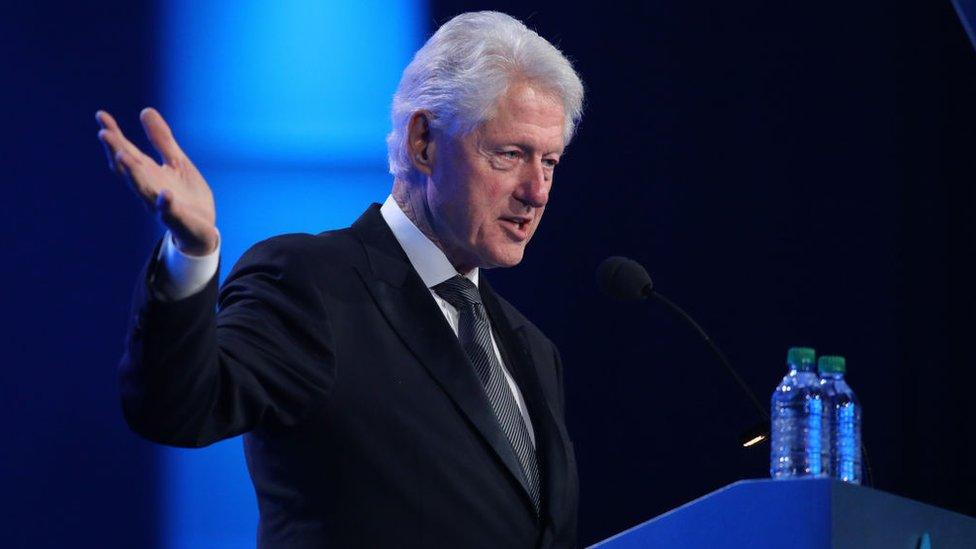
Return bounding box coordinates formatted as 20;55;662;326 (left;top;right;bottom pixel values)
0;0;976;547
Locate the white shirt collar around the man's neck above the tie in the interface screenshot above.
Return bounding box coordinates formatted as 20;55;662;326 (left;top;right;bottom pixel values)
380;195;478;288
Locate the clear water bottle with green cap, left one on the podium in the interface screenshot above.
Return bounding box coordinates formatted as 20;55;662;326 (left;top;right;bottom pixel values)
769;347;830;479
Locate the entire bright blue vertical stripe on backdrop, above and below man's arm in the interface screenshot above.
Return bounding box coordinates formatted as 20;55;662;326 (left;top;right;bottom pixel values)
158;0;427;549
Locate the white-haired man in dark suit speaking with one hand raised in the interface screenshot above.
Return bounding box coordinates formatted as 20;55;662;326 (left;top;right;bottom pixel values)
97;12;583;547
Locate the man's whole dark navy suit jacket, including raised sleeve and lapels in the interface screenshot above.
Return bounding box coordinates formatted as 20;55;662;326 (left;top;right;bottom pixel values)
120;204;578;548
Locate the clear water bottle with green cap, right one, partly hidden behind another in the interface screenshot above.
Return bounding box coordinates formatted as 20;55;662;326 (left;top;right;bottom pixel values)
817;356;861;484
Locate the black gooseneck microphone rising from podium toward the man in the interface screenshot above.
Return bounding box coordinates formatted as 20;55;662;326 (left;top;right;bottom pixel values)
596;256;770;448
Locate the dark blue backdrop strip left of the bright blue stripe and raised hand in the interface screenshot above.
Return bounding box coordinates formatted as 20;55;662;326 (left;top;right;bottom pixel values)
0;1;158;547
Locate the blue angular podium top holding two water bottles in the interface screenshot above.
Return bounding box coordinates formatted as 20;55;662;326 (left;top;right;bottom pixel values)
592;478;976;549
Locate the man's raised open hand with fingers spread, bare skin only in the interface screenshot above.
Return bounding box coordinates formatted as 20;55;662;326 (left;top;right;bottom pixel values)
95;108;219;255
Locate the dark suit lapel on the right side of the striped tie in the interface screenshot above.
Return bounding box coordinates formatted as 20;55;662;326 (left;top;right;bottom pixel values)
478;275;569;524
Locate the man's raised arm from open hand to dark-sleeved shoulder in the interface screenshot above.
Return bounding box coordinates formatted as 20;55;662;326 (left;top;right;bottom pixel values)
96;109;334;446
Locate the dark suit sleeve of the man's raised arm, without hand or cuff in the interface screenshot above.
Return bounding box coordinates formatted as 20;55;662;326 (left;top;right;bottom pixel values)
119;230;335;447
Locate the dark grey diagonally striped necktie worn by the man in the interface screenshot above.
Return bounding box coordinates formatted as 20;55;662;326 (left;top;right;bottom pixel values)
434;275;539;514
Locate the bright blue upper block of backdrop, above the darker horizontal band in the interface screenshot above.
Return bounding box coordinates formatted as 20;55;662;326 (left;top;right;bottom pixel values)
160;0;425;162
